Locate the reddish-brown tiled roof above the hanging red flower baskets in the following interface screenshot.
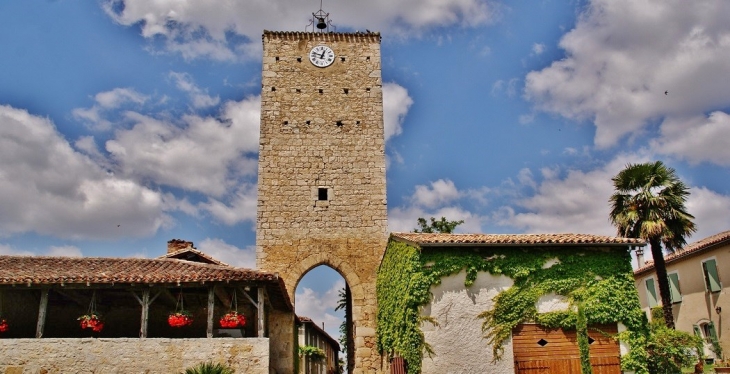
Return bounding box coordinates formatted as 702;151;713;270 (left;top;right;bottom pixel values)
0;256;292;310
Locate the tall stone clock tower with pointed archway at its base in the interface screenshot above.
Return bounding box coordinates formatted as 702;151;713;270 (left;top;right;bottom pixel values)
256;31;387;373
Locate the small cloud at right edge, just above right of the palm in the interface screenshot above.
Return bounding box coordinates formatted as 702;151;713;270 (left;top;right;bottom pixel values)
651;111;730;166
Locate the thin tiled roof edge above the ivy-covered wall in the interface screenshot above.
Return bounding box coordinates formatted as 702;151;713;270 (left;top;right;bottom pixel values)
391;232;646;247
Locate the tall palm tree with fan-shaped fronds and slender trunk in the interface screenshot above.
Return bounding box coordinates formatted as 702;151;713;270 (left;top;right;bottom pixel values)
609;161;697;329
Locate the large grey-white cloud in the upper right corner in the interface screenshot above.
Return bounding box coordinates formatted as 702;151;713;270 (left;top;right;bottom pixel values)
525;0;730;147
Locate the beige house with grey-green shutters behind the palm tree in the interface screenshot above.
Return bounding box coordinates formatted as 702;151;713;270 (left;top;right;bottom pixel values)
634;231;730;358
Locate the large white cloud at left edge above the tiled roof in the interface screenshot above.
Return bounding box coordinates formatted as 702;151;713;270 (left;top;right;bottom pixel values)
0;106;169;239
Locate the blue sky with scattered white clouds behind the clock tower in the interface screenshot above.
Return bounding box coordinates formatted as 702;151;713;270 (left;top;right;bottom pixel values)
0;0;730;344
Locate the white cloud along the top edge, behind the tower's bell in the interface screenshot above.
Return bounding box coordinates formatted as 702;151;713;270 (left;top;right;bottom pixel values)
104;0;493;60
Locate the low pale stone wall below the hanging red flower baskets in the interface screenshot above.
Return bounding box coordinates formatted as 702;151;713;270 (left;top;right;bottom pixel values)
0;338;269;374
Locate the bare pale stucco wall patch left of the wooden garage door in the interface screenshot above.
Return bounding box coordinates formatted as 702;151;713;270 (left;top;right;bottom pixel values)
421;272;515;374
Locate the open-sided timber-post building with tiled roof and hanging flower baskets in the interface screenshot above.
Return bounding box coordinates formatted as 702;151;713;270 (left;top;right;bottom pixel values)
0;240;294;374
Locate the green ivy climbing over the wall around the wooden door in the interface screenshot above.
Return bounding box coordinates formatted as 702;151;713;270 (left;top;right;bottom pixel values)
377;240;647;373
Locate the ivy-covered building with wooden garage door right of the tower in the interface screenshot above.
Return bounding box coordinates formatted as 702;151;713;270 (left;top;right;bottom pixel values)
378;233;646;374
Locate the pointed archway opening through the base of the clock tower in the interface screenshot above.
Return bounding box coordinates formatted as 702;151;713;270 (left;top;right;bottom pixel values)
294;265;355;374
